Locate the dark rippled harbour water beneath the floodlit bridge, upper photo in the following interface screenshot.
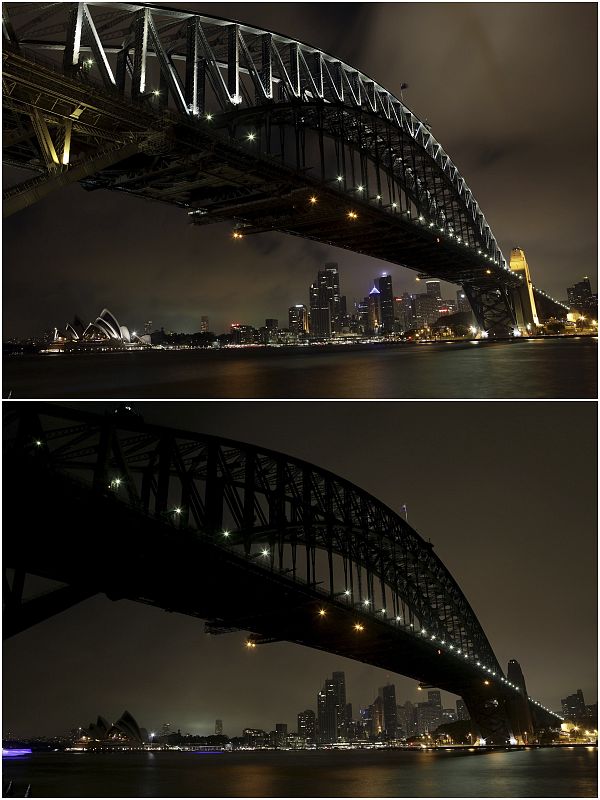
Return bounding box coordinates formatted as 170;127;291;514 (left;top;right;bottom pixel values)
3;338;598;400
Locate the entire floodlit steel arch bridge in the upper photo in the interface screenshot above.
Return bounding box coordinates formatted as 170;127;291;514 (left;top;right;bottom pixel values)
2;2;566;335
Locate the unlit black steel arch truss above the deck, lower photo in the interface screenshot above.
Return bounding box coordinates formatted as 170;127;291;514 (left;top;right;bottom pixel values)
5;405;502;675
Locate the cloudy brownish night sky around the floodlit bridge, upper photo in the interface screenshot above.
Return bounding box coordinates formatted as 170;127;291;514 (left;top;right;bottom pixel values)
3;3;597;337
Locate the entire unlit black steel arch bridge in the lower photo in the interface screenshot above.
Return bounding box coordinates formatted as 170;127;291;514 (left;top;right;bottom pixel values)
4;403;560;744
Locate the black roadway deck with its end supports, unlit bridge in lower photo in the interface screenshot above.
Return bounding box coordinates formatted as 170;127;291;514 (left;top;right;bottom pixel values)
4;406;556;744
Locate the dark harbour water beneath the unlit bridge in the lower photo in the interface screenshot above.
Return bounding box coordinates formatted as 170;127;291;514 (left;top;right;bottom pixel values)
3;747;597;797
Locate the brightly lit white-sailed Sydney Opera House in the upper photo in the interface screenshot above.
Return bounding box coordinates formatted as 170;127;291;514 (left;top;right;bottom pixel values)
48;308;150;352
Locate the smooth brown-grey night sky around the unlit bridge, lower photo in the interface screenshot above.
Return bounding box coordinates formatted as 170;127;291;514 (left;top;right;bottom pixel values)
3;402;597;736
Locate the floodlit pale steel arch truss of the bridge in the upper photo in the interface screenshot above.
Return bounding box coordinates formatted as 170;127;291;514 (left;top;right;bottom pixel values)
5;3;505;266
